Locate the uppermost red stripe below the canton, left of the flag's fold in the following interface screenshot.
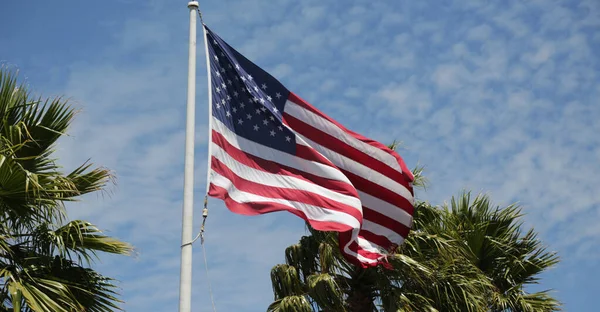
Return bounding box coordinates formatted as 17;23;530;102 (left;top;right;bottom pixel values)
212;130;358;198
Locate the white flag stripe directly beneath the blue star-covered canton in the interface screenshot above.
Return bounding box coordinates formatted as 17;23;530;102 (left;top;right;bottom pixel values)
212;117;352;186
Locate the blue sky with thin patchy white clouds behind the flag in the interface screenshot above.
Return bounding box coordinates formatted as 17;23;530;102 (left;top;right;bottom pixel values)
0;0;600;312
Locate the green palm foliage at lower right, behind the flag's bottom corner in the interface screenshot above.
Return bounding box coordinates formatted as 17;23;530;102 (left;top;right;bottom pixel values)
268;170;559;312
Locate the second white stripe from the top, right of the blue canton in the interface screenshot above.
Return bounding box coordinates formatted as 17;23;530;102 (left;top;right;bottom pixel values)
296;134;414;208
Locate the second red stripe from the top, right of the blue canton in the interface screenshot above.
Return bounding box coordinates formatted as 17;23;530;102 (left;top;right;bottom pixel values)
283;113;409;188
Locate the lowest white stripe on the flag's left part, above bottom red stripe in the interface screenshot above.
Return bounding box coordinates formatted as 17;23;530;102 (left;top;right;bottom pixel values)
211;170;360;229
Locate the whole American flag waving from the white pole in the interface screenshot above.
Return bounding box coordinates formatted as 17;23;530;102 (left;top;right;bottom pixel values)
203;25;414;267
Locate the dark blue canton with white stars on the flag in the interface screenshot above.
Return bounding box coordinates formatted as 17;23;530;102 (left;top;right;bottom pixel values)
204;26;296;154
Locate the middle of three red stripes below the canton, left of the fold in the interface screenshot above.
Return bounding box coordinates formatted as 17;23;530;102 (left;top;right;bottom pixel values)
211;156;362;222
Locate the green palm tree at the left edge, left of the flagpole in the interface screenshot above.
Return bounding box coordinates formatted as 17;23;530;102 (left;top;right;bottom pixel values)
0;68;132;312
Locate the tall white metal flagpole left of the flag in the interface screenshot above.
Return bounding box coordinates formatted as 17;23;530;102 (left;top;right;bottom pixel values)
179;1;198;312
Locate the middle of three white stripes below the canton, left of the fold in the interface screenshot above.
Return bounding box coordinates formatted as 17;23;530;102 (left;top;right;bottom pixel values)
212;143;362;213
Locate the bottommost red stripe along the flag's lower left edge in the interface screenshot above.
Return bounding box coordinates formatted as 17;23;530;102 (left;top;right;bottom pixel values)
208;183;351;232
